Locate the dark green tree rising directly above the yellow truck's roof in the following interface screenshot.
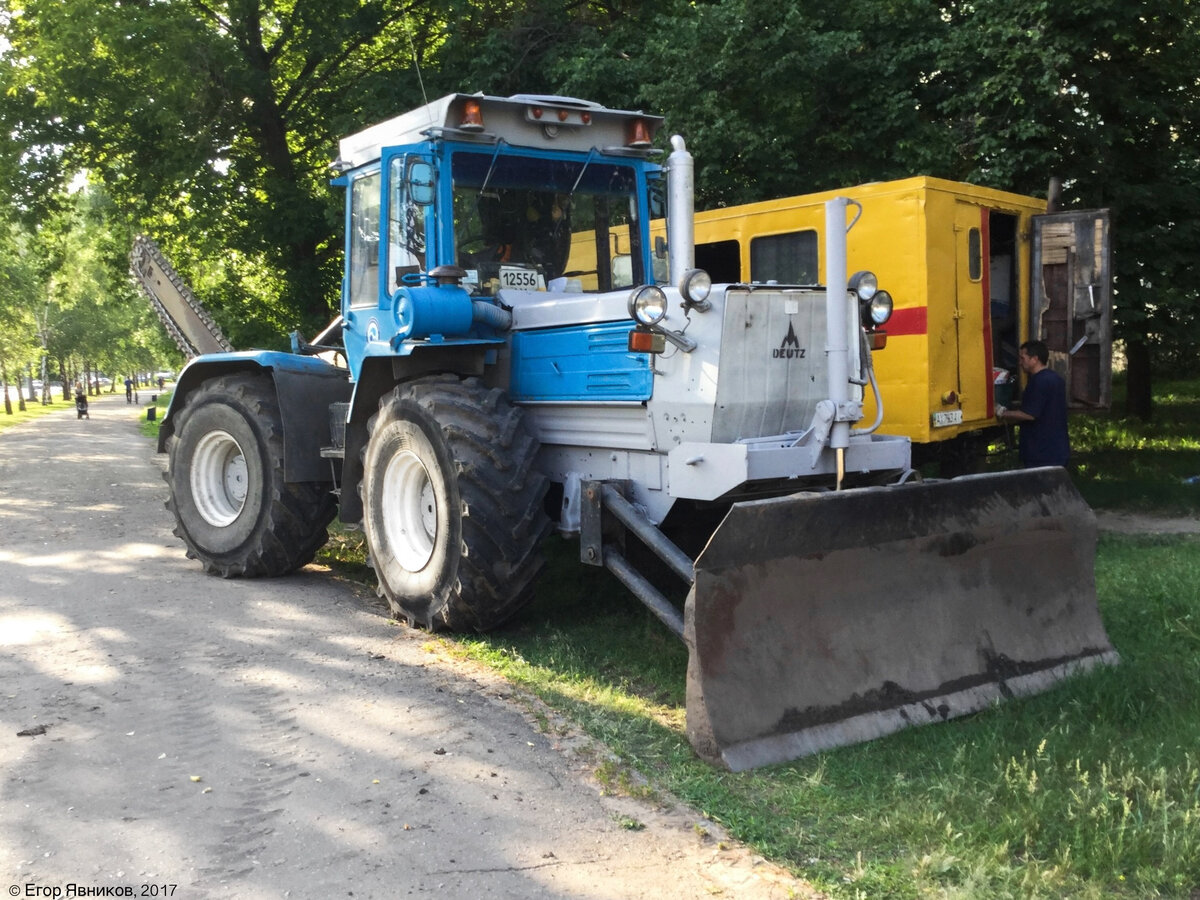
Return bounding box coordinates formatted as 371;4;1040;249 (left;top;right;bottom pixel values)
644;0;942;205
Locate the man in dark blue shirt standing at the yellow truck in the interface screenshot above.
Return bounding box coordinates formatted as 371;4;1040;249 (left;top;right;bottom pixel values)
996;341;1070;469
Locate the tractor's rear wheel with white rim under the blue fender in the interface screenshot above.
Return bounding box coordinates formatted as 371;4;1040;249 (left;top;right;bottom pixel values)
166;374;337;578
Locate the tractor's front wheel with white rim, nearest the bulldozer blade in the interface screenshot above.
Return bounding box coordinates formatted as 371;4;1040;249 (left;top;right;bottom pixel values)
360;376;550;631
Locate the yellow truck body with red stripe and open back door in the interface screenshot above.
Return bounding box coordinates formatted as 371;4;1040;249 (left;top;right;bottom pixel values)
695;176;1112;470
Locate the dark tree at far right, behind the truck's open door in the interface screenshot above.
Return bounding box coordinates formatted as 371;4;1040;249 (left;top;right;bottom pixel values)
924;0;1200;418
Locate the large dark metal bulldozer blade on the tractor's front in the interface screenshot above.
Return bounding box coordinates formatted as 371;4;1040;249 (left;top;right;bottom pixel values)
684;468;1117;772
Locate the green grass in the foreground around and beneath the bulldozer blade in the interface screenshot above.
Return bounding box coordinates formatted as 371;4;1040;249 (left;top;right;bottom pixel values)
324;535;1200;898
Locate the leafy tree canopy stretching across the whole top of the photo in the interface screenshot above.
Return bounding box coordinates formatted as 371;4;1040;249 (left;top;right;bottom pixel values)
0;0;1200;397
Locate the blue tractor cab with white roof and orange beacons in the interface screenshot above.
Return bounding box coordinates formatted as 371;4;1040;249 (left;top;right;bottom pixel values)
334;94;661;377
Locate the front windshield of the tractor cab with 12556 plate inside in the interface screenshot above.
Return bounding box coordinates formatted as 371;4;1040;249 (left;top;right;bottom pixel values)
451;151;643;295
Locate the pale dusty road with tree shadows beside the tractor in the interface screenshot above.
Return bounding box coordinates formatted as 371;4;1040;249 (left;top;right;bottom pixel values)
0;395;809;900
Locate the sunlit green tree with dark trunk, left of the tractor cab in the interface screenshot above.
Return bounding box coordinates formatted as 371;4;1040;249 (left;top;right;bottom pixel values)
6;0;438;343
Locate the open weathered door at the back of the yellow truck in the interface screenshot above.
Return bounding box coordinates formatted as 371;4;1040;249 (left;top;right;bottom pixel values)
1028;209;1112;409
